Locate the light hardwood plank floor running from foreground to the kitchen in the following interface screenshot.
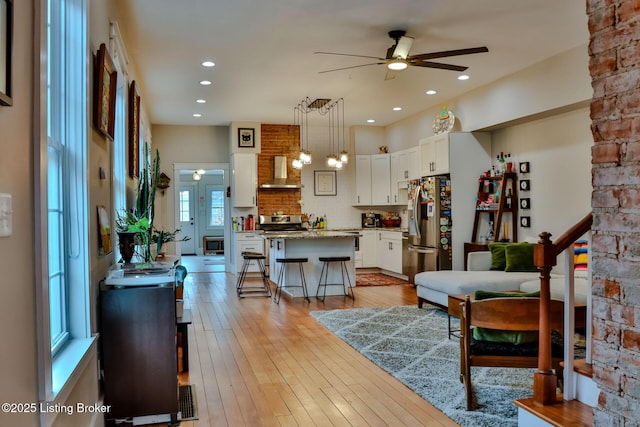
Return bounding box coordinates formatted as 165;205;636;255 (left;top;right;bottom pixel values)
170;273;457;427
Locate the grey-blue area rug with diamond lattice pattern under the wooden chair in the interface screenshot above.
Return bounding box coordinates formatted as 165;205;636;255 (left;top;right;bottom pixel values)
311;306;535;427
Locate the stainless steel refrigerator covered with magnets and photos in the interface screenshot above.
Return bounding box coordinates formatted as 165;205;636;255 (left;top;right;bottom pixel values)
402;175;452;283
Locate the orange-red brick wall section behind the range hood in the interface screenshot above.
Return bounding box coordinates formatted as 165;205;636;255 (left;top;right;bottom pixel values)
258;125;302;215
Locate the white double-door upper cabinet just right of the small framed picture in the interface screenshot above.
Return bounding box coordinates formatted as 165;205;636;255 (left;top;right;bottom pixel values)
355;154;391;206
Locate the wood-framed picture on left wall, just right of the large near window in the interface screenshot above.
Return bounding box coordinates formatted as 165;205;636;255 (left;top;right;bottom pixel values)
93;43;117;139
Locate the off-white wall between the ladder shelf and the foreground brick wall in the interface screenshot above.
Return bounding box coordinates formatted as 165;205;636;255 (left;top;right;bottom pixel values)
492;108;593;240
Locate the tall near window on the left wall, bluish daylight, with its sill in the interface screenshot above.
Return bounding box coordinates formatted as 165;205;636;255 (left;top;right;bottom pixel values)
35;0;95;406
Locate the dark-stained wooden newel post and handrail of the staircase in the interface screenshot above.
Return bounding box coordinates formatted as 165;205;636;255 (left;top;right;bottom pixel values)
533;213;593;405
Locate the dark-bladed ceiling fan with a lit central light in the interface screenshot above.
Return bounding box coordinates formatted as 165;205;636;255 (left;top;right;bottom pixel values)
314;30;489;80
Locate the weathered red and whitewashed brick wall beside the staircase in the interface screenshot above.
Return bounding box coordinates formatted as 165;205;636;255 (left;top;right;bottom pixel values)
587;0;640;426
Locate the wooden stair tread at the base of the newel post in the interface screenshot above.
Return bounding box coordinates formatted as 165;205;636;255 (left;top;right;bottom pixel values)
514;395;593;427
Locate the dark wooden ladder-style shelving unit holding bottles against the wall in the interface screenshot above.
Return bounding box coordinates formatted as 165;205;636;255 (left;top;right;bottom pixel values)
471;172;518;242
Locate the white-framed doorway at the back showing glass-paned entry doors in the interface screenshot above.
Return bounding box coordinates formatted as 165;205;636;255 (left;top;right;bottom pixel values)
174;163;231;266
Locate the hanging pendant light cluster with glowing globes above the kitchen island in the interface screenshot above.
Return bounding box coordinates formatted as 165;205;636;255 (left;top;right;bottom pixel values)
292;97;349;169
